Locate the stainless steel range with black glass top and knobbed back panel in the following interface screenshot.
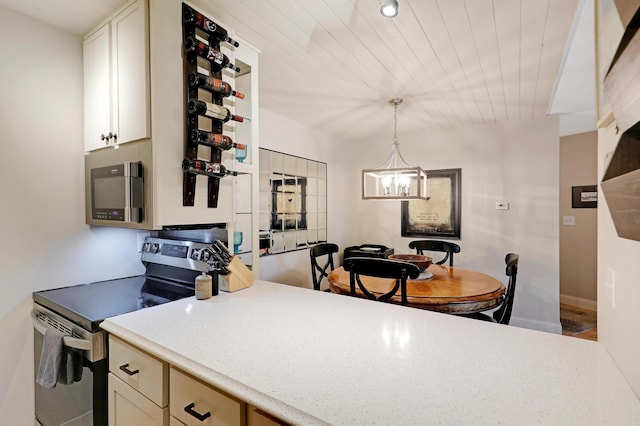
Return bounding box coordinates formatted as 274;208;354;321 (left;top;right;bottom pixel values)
32;230;226;426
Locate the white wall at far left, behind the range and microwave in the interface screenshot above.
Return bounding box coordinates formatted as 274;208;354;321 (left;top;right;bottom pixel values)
0;7;144;426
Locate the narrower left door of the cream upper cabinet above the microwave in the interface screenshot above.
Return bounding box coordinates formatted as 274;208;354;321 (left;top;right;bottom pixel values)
83;25;111;151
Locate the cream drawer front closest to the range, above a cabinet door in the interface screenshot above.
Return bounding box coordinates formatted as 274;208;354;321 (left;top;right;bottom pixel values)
109;336;169;407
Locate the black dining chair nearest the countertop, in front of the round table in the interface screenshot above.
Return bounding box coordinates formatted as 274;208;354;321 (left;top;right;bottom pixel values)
343;257;420;306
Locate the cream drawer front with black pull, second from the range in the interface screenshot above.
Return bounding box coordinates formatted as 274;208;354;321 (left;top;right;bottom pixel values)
169;367;246;426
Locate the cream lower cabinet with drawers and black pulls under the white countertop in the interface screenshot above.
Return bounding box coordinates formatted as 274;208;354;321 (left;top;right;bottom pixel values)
109;336;287;426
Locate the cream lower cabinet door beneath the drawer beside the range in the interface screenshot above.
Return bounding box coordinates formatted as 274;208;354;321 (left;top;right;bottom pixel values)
109;373;169;426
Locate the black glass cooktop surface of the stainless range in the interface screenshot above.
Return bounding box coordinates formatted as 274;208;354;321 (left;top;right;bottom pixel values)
33;275;195;331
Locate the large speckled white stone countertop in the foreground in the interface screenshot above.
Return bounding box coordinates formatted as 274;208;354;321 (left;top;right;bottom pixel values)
102;281;640;426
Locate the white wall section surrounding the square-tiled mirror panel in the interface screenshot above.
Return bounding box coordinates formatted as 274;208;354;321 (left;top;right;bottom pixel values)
260;109;359;288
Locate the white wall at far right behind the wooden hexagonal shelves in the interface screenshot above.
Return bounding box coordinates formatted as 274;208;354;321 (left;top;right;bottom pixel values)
598;121;640;396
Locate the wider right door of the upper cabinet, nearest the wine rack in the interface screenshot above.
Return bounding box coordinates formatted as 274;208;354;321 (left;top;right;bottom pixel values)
111;0;151;143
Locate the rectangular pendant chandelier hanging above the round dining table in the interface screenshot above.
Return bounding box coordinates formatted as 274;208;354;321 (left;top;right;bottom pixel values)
362;98;429;200
